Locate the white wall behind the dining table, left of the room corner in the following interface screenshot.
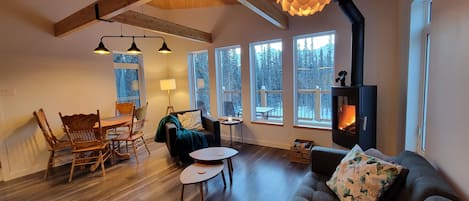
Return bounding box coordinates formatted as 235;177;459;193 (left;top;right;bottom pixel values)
0;0;170;180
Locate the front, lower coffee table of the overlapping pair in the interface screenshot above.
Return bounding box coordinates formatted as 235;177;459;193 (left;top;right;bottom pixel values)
179;163;226;201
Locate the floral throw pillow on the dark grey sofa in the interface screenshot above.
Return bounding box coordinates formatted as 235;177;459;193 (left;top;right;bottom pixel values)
326;145;403;201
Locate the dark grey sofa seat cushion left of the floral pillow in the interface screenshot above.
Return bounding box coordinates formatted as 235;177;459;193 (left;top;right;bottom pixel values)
292;172;338;201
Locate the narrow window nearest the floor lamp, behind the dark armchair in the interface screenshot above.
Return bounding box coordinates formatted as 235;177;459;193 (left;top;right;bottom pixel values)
189;51;210;116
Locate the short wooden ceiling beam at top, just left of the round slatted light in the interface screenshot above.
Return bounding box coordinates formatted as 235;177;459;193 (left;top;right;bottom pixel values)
238;0;288;29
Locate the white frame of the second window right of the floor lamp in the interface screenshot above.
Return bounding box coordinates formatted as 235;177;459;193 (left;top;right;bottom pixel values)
215;45;239;118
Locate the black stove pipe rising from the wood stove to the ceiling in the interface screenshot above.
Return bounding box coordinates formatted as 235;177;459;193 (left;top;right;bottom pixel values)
335;0;365;86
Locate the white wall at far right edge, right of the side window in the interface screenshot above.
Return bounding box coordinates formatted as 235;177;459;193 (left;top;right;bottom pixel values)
425;0;469;200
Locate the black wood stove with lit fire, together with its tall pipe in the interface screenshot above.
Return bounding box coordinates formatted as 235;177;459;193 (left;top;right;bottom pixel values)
331;0;377;149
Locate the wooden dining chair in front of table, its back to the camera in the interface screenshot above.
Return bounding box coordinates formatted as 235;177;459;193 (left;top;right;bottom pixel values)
59;110;112;182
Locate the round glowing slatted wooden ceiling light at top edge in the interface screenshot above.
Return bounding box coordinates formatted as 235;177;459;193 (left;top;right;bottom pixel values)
277;0;331;16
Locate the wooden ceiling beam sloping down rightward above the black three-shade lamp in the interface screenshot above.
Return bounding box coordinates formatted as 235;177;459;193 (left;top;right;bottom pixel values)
112;10;212;43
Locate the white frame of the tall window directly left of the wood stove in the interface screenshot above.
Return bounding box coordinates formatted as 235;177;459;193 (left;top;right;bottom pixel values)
292;30;337;129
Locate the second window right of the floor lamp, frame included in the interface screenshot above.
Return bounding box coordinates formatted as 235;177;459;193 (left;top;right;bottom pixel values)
215;45;242;117
